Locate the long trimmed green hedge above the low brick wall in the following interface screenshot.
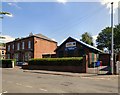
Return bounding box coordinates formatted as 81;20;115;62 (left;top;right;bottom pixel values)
28;57;83;66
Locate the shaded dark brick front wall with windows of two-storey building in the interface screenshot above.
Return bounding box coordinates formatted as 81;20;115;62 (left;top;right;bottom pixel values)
6;37;34;61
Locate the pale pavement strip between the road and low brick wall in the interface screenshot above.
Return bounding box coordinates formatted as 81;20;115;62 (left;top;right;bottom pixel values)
14;67;118;80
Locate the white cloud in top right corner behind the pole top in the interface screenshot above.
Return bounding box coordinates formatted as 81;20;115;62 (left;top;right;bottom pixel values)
100;0;120;13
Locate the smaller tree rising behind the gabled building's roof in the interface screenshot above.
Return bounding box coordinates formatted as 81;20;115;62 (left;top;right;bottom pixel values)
80;32;93;45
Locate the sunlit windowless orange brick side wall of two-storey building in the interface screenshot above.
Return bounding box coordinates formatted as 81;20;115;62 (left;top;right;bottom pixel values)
34;37;57;58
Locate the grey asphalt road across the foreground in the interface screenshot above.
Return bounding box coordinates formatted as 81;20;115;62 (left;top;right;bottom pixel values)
2;68;118;93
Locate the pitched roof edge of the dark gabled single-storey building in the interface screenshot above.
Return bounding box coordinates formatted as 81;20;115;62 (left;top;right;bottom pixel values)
55;37;103;52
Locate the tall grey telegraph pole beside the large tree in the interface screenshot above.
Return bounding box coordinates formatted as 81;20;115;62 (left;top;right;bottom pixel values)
111;2;114;74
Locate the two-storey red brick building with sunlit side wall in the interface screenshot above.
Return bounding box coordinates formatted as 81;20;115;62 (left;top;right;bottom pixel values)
6;34;57;61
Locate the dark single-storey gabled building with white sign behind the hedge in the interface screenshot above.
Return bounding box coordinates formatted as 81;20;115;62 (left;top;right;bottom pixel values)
55;37;102;64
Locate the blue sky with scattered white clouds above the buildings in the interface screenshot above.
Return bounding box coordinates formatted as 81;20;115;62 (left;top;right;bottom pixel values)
0;0;118;45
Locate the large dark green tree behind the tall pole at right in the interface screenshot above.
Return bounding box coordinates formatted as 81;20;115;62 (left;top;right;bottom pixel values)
96;24;120;50
